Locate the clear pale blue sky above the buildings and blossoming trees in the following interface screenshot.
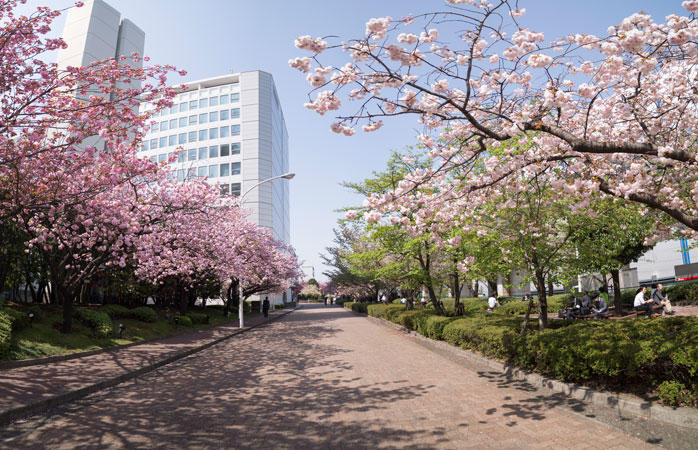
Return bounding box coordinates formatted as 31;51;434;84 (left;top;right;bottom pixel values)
28;0;685;278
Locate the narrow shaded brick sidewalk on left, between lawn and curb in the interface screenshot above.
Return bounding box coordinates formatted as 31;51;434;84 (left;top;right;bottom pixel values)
0;310;288;426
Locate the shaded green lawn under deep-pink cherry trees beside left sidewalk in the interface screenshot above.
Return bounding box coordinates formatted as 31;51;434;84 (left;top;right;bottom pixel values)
2;304;253;360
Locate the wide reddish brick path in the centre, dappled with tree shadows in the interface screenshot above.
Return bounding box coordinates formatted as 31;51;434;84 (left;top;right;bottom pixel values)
0;305;695;449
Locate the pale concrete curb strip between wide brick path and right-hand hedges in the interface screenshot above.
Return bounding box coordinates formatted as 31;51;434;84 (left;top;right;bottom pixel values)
354;313;698;430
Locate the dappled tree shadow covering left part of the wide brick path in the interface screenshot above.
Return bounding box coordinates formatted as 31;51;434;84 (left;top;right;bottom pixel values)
0;305;443;449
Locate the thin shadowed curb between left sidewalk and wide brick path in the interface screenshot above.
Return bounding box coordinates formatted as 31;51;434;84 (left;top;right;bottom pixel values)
0;307;297;426
